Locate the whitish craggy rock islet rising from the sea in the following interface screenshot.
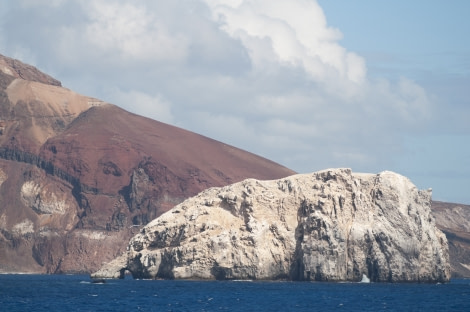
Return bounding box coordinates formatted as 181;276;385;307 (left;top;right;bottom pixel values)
93;169;450;282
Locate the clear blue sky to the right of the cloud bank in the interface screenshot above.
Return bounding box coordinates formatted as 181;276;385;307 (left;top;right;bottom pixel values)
318;0;470;204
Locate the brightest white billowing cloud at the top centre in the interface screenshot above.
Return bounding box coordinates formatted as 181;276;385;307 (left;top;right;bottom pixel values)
206;0;366;82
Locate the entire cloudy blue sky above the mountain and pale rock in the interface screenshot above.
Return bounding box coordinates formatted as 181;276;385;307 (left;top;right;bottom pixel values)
0;0;470;204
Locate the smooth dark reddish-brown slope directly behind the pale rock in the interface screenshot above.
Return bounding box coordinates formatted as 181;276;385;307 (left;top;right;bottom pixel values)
40;104;293;193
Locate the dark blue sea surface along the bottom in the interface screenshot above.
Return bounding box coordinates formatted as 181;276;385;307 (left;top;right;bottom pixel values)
0;274;470;312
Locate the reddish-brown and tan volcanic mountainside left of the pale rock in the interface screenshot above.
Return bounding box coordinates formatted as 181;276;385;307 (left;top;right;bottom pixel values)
0;55;293;273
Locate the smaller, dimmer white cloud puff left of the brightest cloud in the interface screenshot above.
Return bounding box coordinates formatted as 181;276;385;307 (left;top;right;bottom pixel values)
83;1;188;62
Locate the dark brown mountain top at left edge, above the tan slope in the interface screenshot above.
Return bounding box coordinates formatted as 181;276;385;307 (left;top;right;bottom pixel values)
0;54;62;87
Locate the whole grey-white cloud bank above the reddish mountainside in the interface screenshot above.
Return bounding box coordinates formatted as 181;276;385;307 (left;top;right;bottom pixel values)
0;0;433;172
